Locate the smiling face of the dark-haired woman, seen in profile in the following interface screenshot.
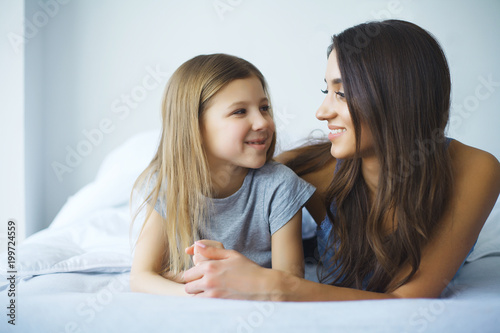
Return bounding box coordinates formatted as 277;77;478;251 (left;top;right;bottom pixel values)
316;50;373;159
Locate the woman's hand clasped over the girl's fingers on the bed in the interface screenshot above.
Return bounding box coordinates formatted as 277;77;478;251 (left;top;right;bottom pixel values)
184;242;288;300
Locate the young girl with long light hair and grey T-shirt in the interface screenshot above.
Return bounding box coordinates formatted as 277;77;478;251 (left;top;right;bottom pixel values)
130;54;314;295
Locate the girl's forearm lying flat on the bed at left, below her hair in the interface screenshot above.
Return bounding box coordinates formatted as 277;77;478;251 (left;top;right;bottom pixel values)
130;272;190;296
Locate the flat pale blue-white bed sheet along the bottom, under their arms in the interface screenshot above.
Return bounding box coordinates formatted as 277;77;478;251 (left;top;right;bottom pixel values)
0;256;500;333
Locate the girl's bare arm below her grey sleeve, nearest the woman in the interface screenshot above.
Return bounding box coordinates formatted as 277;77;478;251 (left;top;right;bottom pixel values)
271;209;304;277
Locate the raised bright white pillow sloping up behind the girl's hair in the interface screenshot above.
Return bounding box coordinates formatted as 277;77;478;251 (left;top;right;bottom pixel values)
50;130;160;228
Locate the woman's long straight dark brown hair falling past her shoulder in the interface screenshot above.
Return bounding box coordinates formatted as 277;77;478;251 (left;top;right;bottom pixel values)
290;20;452;292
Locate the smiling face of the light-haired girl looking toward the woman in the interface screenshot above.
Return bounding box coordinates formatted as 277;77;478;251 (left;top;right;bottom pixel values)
201;76;274;169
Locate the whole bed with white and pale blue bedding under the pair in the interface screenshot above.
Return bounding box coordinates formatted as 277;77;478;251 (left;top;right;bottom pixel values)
0;131;500;332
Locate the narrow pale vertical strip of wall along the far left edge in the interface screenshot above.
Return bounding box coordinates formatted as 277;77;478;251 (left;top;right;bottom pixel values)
0;1;25;245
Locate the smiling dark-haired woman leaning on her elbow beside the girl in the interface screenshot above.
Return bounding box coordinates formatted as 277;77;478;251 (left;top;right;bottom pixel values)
184;20;500;301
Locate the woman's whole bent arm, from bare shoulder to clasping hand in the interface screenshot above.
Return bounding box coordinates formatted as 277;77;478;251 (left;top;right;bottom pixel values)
184;141;500;301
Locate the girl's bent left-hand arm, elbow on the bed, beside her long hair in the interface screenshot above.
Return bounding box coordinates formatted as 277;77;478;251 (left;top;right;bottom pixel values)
130;206;188;296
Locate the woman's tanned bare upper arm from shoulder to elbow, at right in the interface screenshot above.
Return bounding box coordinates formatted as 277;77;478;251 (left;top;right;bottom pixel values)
388;140;500;297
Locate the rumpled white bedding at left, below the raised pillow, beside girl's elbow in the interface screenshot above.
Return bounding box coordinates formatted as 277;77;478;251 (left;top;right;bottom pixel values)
0;205;132;280
